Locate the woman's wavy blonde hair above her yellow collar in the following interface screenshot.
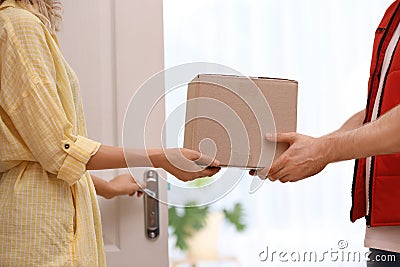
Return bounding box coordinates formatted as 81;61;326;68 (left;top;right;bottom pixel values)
0;0;62;31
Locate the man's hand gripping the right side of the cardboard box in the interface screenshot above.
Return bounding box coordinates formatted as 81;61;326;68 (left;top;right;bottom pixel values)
251;133;330;183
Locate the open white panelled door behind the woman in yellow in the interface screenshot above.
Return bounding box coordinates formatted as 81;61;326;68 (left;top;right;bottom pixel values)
59;0;168;267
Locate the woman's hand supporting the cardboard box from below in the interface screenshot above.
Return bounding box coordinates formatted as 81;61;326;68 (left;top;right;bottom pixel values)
148;148;221;182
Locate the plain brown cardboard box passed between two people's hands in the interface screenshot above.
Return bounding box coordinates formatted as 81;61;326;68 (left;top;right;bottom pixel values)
184;74;298;169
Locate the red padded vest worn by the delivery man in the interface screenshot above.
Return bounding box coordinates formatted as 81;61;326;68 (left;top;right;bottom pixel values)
351;0;400;226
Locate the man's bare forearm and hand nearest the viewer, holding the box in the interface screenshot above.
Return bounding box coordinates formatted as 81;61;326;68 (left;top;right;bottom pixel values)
267;106;400;182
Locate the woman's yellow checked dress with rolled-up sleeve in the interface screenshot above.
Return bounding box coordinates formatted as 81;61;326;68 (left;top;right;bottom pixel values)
0;0;105;267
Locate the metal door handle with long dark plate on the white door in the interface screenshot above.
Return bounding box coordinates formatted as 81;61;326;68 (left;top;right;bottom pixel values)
144;170;160;240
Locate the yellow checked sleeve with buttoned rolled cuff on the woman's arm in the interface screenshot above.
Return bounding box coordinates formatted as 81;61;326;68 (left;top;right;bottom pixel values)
0;11;100;185
